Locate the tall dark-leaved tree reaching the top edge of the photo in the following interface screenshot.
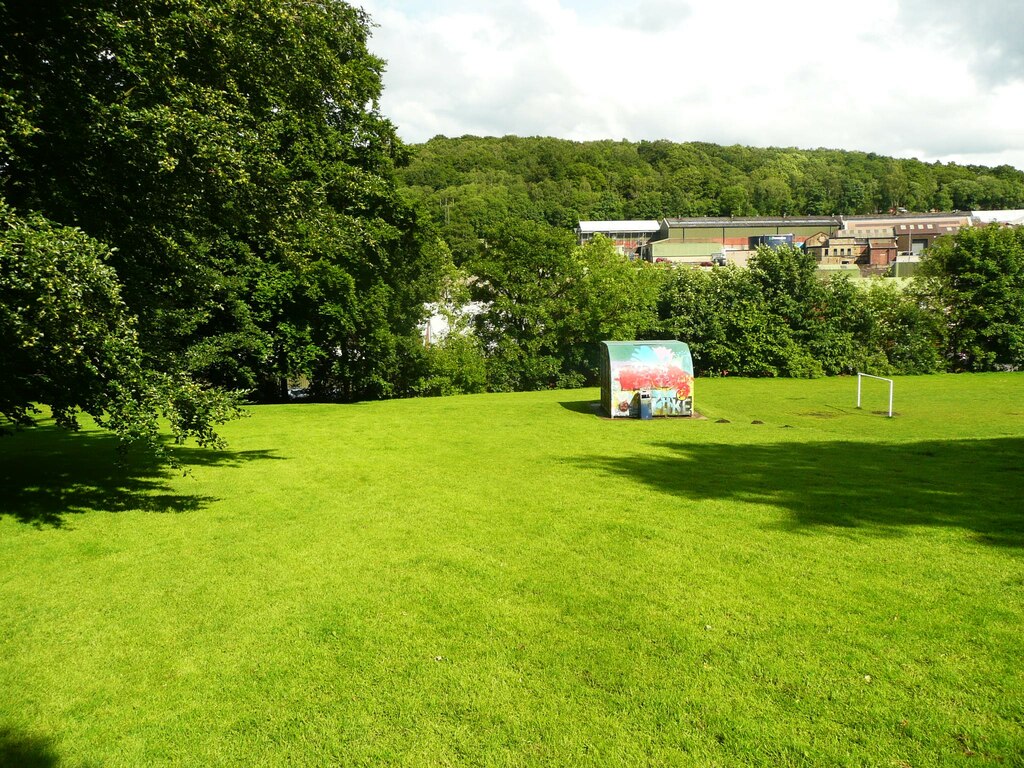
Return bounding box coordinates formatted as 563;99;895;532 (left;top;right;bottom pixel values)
0;0;432;397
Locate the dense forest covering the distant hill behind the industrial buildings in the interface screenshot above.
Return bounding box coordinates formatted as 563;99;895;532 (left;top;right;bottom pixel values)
398;136;1024;256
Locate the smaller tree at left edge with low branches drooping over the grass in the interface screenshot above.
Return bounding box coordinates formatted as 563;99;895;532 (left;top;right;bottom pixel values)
0;203;240;458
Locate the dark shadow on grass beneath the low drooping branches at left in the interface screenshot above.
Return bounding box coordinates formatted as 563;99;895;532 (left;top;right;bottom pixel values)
0;426;276;527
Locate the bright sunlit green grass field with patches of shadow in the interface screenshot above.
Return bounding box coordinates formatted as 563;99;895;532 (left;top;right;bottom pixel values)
0;374;1024;768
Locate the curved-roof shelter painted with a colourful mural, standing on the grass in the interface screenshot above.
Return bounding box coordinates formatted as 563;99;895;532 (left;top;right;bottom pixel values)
602;341;693;418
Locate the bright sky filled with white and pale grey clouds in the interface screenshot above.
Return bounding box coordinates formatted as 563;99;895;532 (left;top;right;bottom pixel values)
355;0;1024;170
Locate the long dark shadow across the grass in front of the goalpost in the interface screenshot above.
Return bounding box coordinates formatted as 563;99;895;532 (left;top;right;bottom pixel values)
581;437;1024;548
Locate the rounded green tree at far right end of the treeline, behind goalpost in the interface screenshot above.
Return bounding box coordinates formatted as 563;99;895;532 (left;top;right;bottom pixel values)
920;225;1024;371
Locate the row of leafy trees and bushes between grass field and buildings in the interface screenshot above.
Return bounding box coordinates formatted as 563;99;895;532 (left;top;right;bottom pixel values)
418;222;1024;394
